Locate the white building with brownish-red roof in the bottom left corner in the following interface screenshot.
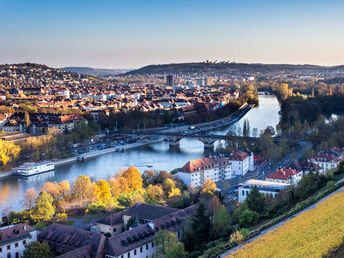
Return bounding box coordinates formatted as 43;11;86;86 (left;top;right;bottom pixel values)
0;223;37;258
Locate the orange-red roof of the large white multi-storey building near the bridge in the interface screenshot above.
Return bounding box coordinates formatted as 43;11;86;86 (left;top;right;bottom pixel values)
180;156;230;173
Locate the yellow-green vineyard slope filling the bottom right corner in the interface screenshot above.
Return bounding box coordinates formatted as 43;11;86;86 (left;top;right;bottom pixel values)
229;189;344;258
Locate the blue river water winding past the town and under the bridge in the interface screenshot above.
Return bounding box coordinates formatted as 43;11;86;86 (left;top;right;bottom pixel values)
0;95;280;212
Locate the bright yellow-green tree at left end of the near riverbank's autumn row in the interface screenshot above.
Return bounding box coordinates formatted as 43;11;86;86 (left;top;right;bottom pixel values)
31;191;55;222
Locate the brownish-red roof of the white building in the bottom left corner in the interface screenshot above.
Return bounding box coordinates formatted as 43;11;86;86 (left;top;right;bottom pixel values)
0;223;35;244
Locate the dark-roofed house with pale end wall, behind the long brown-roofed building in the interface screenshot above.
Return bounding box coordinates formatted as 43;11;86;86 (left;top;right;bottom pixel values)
96;203;178;235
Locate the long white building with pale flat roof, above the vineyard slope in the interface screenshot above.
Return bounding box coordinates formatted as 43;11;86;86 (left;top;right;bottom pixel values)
238;179;290;202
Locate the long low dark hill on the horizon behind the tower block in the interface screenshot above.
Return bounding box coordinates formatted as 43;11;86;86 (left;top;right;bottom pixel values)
124;62;330;76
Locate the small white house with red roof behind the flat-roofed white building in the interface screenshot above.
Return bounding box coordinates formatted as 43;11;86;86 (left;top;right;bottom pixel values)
266;168;303;185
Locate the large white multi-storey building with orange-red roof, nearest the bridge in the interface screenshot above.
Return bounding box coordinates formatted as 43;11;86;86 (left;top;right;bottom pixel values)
177;156;232;187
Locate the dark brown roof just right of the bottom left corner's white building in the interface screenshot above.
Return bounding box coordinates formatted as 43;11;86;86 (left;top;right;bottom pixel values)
38;223;105;257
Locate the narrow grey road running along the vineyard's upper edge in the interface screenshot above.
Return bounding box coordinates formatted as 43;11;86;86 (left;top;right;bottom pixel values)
219;182;344;257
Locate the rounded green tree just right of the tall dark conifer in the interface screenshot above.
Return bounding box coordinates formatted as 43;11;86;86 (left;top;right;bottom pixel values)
212;206;232;238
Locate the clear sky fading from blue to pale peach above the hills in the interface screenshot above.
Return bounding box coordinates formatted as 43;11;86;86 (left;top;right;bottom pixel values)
0;0;344;69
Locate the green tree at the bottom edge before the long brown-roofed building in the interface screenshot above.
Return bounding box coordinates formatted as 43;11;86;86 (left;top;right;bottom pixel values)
155;230;186;258
